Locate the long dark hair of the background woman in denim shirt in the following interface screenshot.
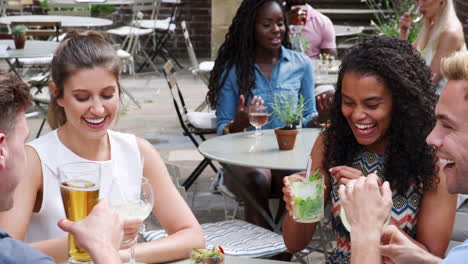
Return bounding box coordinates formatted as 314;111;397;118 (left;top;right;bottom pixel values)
206;0;291;109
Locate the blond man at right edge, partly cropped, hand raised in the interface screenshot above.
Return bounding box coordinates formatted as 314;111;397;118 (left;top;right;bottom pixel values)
339;51;468;264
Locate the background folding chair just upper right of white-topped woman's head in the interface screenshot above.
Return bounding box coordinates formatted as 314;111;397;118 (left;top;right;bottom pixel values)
107;0;159;72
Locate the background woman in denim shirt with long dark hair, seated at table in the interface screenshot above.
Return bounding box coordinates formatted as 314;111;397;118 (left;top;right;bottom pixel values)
207;0;316;235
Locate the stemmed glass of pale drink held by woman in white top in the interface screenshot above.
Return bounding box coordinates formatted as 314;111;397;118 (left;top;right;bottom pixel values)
113;177;154;264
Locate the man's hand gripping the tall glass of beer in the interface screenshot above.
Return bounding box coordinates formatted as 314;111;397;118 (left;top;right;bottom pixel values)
58;200;123;259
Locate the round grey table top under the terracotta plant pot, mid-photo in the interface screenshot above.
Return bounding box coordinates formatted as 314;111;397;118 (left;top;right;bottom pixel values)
198;128;320;171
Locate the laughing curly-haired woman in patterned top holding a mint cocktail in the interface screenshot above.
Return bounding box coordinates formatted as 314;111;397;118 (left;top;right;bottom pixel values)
283;36;456;263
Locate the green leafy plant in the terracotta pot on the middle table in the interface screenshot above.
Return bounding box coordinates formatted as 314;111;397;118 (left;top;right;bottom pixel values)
271;93;304;130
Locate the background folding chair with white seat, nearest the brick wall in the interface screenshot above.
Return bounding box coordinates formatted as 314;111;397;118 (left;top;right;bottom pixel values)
135;0;183;70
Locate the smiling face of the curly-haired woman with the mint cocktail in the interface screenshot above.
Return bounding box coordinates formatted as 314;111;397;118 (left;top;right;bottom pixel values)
341;72;392;153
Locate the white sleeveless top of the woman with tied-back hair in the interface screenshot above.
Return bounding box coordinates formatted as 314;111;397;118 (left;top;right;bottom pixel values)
25;130;143;243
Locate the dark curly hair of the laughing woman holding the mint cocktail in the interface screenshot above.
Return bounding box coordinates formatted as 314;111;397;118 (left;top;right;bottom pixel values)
323;36;439;193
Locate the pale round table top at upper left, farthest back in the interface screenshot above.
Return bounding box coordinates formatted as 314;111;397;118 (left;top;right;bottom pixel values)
0;15;113;27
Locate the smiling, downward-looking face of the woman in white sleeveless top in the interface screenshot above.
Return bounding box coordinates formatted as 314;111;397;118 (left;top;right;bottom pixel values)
57;67;119;139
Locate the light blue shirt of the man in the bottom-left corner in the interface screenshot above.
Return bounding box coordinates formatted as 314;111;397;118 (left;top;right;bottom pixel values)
0;230;55;264
